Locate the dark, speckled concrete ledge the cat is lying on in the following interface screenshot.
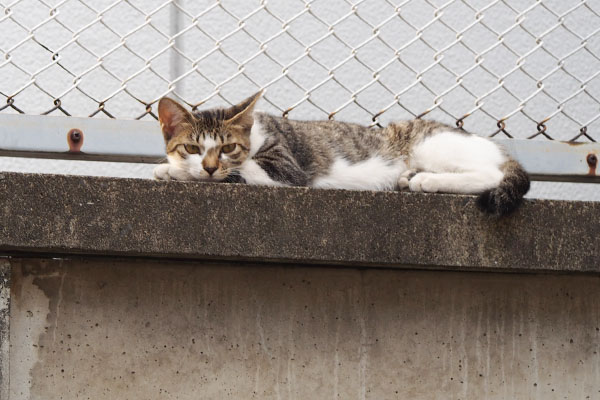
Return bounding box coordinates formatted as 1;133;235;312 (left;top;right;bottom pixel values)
0;173;600;272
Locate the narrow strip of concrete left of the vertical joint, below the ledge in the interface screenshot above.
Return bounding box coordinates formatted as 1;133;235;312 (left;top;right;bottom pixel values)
0;259;11;399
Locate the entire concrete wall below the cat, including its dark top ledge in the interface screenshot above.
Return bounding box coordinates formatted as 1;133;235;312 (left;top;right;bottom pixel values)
0;173;600;400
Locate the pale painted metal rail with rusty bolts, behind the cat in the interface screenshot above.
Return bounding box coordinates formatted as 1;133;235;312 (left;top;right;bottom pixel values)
0;115;600;182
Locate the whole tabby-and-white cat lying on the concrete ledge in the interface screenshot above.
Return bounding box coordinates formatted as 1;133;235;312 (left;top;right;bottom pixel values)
154;92;529;216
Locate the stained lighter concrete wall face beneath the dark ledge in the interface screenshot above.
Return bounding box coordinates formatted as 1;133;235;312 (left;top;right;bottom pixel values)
10;259;600;400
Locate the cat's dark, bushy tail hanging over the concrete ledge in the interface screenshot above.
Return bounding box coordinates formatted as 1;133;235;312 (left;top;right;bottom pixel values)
477;159;529;216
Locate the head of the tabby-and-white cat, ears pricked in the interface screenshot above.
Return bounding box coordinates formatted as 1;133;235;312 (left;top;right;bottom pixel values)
158;91;262;182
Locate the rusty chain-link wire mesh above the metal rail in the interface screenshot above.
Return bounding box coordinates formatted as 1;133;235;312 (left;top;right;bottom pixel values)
0;0;600;141
